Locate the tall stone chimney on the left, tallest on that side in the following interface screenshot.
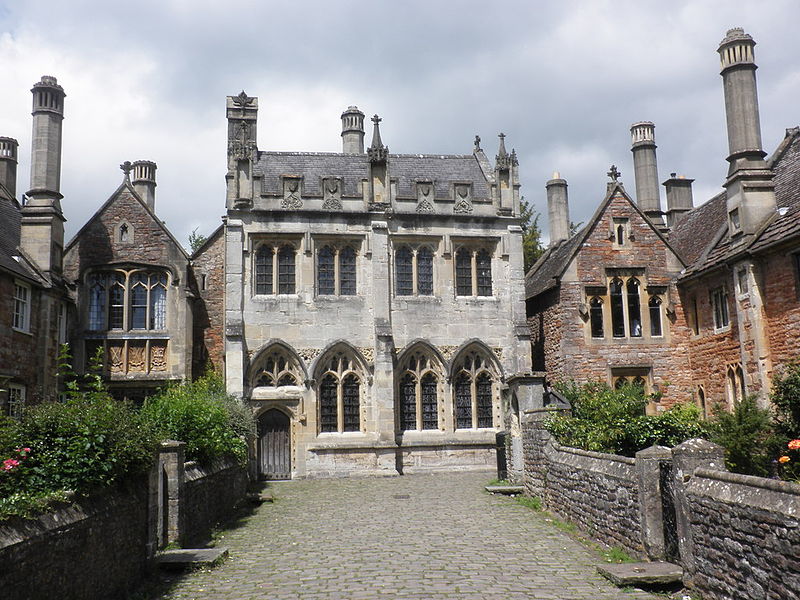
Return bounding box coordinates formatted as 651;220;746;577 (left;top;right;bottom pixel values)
20;75;66;275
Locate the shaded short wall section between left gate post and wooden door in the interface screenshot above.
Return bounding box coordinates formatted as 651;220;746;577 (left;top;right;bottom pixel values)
181;461;248;547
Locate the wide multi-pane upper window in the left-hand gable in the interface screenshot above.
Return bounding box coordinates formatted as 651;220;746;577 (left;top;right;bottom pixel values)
86;267;170;332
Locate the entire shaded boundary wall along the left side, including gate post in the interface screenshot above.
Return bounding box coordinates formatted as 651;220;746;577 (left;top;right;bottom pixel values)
0;442;248;600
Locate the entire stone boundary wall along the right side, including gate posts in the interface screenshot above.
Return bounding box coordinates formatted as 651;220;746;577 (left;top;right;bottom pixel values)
522;410;800;600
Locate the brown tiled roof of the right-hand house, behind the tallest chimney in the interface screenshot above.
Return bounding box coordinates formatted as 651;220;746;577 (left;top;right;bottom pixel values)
670;127;800;276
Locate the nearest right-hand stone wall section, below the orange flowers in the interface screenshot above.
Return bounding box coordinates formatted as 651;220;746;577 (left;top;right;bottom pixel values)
686;469;800;600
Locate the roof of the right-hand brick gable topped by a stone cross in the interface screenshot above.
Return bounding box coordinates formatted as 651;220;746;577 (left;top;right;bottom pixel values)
525;181;681;299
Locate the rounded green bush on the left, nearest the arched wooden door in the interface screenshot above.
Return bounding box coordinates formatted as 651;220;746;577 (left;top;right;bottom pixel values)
142;374;255;465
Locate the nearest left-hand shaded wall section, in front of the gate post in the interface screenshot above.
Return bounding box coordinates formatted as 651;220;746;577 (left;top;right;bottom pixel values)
0;479;150;600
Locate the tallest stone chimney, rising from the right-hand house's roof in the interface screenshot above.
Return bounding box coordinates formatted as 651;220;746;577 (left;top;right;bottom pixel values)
717;27;776;240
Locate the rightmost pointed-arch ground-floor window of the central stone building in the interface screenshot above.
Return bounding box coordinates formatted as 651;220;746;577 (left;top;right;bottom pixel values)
454;350;497;429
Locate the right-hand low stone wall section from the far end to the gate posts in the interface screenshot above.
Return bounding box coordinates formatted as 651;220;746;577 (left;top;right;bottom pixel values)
543;444;644;556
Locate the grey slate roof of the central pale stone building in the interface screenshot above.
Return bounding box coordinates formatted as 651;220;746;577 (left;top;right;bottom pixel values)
255;152;490;199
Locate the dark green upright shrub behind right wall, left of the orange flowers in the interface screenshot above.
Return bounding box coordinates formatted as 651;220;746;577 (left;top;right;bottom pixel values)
711;396;776;477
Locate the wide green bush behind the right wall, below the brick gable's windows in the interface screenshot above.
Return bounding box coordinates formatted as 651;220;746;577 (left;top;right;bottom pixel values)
546;382;709;456
